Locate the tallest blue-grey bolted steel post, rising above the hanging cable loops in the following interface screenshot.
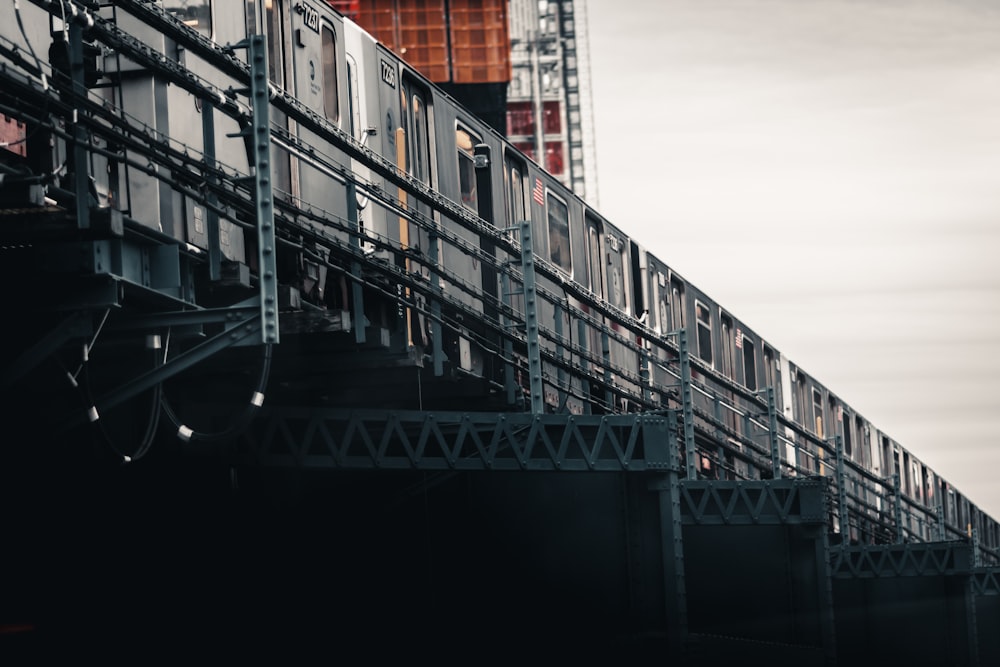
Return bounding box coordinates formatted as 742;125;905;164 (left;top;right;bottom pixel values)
250;35;279;343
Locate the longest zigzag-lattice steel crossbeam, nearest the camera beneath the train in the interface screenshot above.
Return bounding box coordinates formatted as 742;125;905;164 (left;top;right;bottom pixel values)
241;406;671;471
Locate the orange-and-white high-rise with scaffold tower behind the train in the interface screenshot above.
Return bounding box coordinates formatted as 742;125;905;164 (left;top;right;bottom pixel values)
328;0;597;206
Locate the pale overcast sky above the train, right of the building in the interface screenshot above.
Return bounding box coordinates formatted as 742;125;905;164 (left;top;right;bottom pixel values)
587;0;1000;519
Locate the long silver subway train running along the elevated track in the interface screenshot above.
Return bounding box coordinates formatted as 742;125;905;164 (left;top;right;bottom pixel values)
0;0;1000;556
